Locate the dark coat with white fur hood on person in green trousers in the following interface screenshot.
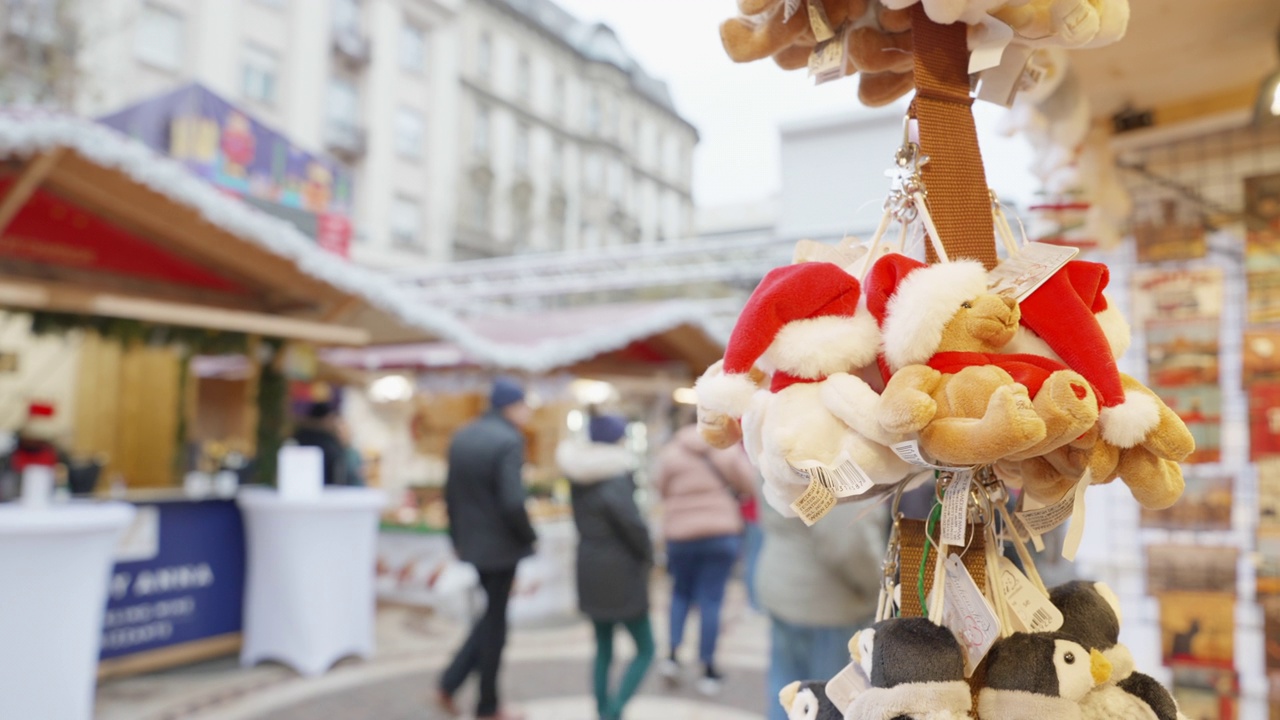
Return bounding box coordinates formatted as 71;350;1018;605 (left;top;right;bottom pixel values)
556;441;653;621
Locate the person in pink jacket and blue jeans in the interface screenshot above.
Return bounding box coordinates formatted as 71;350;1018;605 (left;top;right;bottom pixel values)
654;425;756;694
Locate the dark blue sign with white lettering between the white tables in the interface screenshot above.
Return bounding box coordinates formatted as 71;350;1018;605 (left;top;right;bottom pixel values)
101;500;244;660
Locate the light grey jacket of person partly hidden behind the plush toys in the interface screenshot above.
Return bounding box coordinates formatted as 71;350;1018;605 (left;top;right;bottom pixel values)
755;486;888;626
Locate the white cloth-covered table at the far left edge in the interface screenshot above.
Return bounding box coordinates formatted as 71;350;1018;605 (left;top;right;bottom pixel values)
0;502;134;720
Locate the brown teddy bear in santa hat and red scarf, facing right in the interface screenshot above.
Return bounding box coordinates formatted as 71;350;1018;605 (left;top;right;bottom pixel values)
867;255;1098;465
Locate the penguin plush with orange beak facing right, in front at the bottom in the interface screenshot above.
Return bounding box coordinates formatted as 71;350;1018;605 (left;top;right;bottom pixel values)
978;633;1111;720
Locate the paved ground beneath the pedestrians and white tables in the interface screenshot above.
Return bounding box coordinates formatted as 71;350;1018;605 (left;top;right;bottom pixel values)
95;582;768;720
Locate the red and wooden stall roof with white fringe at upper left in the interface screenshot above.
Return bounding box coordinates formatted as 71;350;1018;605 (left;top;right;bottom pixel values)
0;111;484;345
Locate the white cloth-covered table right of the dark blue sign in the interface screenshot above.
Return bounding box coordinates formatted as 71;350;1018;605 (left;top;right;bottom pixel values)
237;487;387;675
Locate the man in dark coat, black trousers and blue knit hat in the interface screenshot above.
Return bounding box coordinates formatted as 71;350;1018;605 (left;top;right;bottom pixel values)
436;378;538;720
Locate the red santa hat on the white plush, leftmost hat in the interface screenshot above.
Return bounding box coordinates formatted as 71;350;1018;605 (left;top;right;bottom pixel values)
694;263;879;418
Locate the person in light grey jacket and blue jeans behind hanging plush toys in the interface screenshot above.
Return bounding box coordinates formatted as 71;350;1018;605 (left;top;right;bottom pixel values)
755;491;888;720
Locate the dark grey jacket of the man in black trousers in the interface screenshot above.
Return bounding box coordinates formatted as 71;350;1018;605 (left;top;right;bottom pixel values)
444;413;538;571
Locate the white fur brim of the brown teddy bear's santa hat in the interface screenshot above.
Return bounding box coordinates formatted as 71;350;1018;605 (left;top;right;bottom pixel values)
883;260;987;372
